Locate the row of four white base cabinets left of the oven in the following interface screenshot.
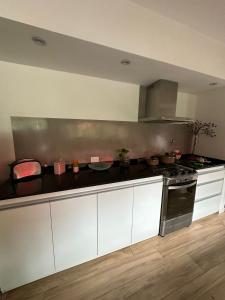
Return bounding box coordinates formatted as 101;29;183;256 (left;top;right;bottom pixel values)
0;176;162;291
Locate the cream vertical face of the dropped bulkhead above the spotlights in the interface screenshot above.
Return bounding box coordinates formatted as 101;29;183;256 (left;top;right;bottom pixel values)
0;0;225;79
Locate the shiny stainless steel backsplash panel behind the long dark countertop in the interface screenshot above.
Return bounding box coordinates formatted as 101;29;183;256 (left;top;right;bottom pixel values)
11;117;191;164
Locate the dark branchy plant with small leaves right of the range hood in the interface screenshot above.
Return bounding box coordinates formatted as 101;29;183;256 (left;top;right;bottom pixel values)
187;120;217;154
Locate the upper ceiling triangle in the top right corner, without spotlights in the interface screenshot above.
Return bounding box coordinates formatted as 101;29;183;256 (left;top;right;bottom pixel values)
130;0;225;43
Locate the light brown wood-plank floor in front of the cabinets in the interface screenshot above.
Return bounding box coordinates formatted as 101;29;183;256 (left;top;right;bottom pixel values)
2;213;225;300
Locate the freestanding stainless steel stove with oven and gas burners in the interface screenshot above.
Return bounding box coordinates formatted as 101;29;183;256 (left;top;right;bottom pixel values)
159;164;197;236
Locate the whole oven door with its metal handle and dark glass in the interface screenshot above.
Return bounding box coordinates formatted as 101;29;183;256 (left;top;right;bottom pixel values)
163;180;196;220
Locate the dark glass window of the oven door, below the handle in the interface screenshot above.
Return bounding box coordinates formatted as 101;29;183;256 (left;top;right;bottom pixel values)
166;185;196;219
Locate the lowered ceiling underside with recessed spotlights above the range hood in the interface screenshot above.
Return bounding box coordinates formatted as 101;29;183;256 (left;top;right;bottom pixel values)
0;18;225;93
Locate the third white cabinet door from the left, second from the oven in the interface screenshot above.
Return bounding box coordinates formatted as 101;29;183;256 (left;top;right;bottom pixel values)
98;187;133;255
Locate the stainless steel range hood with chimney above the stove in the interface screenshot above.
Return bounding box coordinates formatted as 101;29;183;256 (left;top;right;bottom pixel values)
138;79;192;124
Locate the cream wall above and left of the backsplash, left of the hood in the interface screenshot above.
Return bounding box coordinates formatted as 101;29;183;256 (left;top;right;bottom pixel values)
0;62;139;179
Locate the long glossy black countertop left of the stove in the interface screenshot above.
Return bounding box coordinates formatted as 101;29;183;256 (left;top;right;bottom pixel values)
0;160;161;200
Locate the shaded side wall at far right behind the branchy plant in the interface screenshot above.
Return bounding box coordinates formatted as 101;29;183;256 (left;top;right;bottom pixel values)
196;87;225;160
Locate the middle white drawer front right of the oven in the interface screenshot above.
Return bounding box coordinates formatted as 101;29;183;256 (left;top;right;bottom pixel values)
195;180;223;201
